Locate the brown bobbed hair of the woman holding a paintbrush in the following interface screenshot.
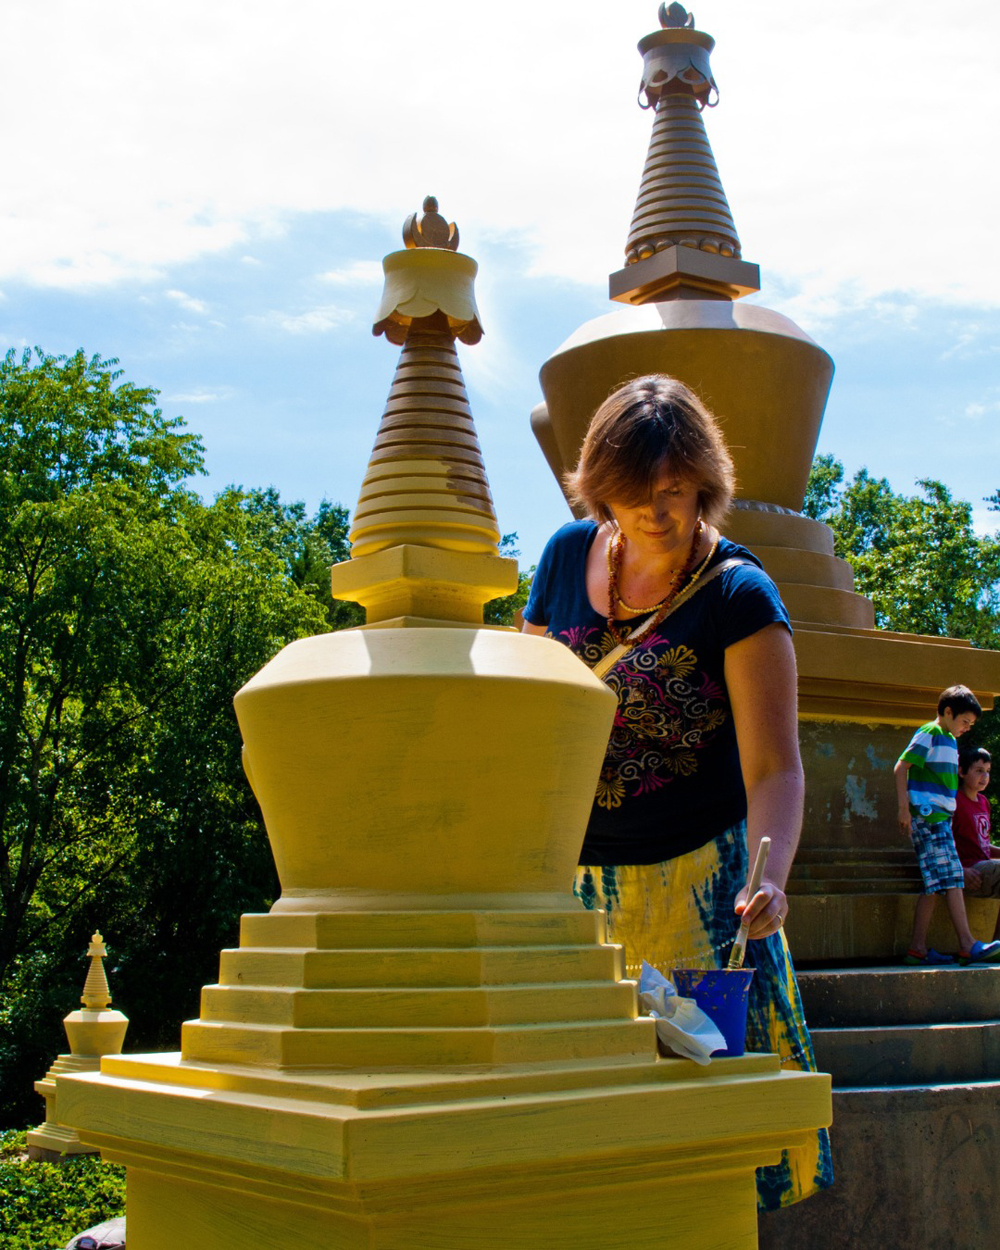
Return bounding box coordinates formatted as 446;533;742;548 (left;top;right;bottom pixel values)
564;374;736;525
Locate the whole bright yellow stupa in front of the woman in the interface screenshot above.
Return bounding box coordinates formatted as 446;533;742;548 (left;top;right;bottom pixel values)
58;206;830;1250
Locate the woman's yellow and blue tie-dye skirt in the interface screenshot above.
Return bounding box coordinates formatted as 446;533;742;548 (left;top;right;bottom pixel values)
574;821;834;1211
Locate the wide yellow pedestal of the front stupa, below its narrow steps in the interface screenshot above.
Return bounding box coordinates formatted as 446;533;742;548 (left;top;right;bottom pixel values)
59;1055;829;1250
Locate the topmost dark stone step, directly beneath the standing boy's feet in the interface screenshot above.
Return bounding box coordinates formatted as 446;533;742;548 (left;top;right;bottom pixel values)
799;964;1000;1030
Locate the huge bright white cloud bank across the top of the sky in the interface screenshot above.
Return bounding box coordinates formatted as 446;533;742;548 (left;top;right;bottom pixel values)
0;0;1000;306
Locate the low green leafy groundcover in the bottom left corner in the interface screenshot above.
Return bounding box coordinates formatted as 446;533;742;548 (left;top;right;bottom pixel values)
0;1130;125;1250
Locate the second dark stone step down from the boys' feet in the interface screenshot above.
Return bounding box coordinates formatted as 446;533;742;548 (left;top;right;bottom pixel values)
810;1020;1000;1089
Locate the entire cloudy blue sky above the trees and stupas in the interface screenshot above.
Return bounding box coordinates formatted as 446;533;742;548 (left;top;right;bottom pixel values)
0;0;1000;561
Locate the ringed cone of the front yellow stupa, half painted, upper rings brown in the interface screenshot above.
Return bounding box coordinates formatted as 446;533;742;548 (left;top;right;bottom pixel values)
350;329;500;558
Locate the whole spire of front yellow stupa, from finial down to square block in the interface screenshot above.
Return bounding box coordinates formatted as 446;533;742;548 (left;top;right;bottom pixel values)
331;196;518;625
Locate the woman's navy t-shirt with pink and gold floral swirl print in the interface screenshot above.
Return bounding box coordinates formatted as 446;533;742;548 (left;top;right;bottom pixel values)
524;521;789;865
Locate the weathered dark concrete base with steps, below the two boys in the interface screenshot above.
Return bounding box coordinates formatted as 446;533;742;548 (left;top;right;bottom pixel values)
759;968;1000;1250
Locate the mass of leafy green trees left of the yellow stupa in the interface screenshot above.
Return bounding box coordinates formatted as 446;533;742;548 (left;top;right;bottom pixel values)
0;349;335;1119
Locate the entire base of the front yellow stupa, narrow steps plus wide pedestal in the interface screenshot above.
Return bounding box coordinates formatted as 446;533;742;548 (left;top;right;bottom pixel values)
58;908;831;1250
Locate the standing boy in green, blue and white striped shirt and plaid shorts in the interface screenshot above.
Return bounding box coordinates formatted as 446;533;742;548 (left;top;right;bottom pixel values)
893;686;1000;964
